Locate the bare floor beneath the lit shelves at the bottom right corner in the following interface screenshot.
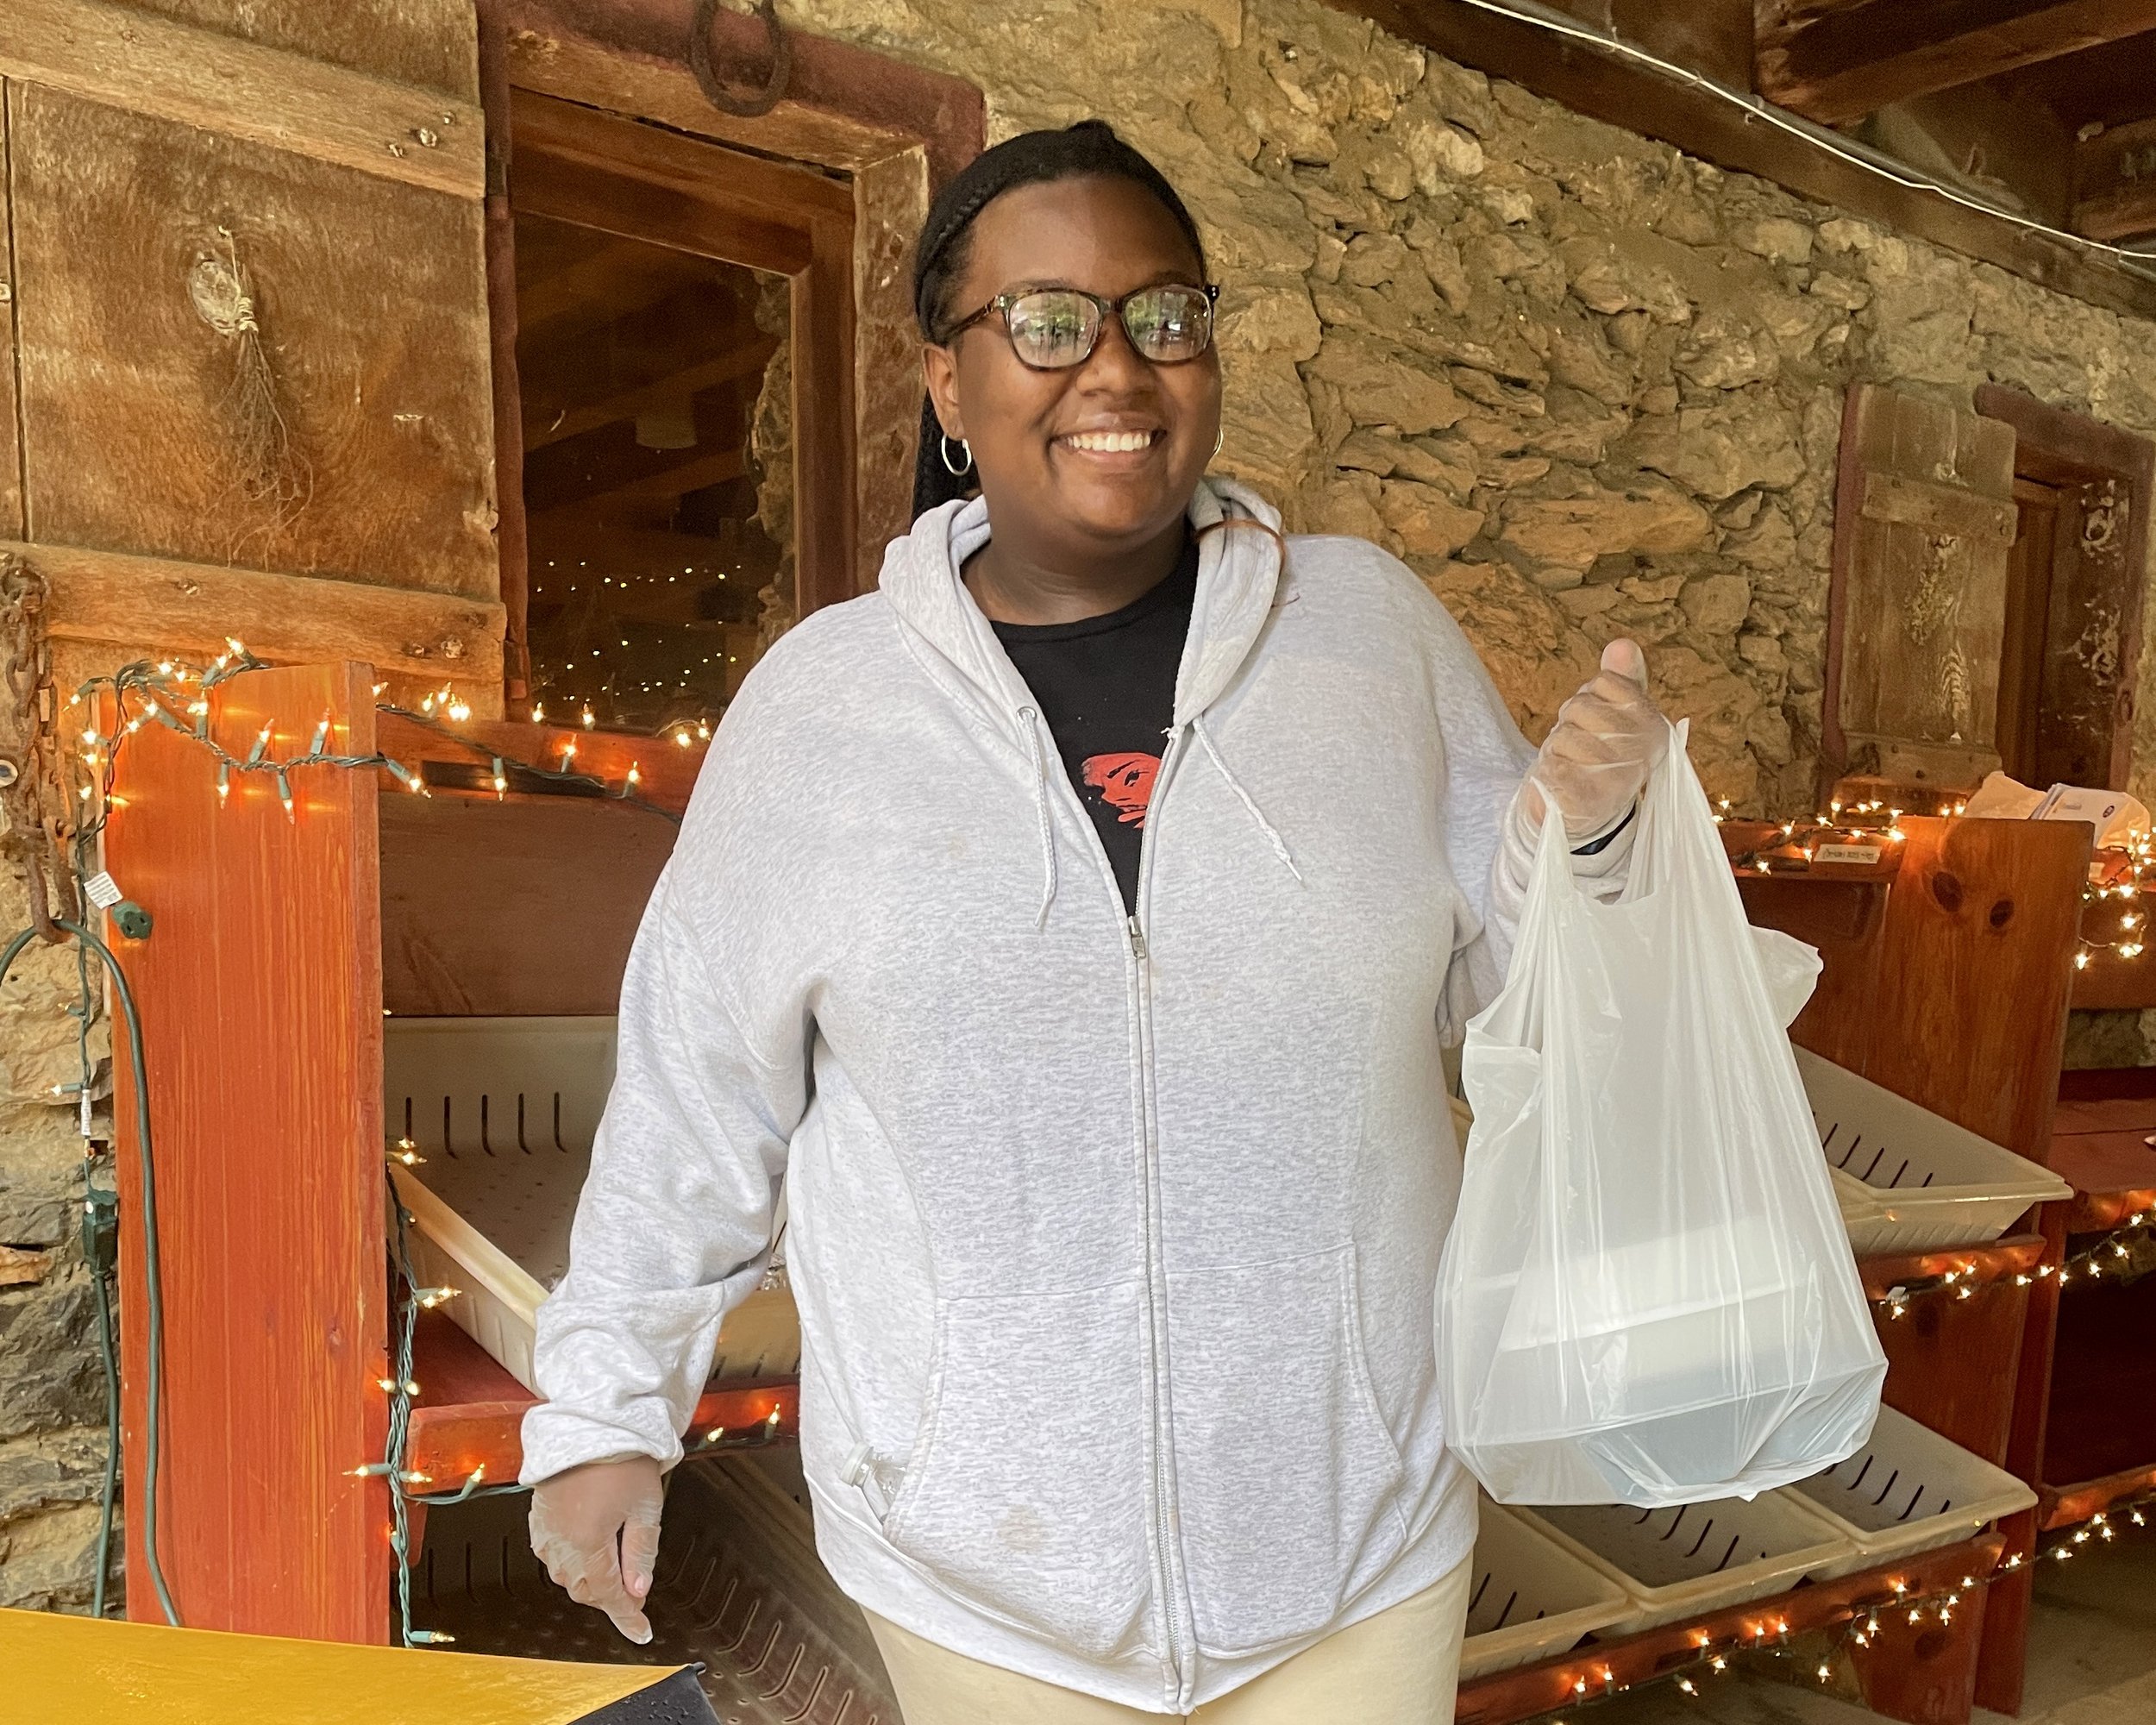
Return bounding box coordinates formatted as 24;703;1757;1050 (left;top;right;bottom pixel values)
1595;1534;2156;1725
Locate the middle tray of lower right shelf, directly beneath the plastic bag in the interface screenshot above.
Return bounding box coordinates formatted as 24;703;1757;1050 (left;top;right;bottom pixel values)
1514;1490;1854;1634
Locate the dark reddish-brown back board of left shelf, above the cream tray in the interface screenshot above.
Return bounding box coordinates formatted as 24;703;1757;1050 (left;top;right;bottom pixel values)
379;796;680;1018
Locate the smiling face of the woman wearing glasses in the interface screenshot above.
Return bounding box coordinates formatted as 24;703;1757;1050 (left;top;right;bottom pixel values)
925;177;1220;563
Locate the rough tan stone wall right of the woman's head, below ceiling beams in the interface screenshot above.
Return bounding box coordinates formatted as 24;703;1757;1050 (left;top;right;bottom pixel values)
780;0;2156;813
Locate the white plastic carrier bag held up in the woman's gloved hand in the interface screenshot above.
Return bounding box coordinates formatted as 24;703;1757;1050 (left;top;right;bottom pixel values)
1438;727;1887;1508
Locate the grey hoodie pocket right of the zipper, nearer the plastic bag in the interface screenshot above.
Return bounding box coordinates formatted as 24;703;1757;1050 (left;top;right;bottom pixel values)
1169;1245;1408;1654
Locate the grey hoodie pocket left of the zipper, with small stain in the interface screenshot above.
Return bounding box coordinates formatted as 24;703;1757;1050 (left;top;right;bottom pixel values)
884;1283;1154;1660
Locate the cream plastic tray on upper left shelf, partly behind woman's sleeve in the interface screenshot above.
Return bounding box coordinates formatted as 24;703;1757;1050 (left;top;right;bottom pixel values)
382;1018;800;1389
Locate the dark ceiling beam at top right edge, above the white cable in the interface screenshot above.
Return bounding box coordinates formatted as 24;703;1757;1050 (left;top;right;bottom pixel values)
1758;0;2156;121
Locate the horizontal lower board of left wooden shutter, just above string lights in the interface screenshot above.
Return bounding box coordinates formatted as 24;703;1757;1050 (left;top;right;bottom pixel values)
15;542;503;706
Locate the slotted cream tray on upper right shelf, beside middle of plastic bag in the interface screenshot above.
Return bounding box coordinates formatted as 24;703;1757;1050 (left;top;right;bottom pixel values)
1794;1048;2072;1258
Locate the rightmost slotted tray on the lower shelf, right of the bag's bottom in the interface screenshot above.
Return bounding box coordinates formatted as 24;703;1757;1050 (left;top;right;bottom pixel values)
1789;1408;2035;1577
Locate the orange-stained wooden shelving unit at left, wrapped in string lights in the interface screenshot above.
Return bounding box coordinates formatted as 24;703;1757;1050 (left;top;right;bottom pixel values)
106;664;724;1641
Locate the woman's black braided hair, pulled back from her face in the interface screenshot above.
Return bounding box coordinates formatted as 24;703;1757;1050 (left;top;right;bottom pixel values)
914;121;1206;516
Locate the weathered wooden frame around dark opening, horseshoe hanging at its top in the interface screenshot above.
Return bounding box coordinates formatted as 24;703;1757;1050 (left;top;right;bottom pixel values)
479;0;987;701
